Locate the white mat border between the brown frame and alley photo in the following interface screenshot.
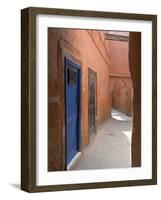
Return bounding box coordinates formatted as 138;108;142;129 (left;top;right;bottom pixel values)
36;15;152;186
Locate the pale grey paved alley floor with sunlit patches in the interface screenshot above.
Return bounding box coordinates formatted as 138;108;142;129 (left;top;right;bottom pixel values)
73;109;132;170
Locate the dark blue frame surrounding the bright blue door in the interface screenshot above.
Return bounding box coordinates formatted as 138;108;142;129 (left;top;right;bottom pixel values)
64;56;82;170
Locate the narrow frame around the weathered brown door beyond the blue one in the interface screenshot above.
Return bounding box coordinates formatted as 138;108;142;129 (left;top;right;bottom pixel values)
88;67;97;142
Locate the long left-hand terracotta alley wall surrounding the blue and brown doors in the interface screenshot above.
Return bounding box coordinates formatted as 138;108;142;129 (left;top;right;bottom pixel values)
48;28;111;170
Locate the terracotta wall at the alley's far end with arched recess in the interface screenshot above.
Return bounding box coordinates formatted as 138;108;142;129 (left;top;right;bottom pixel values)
108;40;133;115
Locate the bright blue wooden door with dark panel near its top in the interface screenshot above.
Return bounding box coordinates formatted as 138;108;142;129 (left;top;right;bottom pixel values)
65;58;80;164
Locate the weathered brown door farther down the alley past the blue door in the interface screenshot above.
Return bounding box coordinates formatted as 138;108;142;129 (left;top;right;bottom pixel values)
88;68;97;139
